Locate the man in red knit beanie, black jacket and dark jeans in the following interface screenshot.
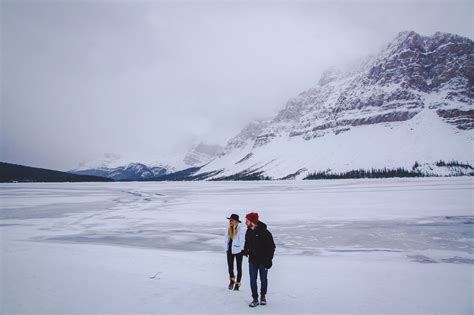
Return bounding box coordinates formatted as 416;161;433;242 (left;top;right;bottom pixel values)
244;212;275;307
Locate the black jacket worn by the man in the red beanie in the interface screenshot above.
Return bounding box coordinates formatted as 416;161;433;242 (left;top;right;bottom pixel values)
244;221;275;269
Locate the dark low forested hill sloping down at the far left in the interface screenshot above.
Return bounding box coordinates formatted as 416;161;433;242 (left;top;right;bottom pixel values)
0;162;113;183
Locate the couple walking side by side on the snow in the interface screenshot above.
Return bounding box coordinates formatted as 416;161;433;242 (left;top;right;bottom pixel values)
225;212;275;307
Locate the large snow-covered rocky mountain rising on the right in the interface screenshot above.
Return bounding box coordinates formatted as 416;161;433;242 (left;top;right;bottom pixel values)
195;32;474;179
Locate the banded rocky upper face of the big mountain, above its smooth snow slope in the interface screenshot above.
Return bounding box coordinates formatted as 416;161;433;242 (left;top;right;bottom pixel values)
264;32;474;145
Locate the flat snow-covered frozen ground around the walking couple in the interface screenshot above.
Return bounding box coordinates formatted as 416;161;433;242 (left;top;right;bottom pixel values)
0;177;474;314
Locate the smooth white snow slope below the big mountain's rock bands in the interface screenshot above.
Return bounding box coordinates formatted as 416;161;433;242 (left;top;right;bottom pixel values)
201;109;473;179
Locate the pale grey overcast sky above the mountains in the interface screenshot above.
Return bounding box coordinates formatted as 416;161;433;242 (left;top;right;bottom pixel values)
0;0;473;170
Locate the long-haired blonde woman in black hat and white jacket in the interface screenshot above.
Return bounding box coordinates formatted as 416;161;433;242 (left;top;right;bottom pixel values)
225;214;245;291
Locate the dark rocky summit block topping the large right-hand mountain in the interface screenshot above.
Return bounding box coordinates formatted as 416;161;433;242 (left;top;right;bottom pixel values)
368;32;474;97
